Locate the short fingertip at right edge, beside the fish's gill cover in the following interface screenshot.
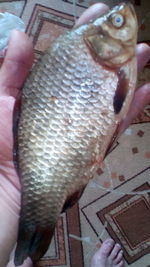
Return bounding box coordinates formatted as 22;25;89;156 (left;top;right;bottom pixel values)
136;43;150;71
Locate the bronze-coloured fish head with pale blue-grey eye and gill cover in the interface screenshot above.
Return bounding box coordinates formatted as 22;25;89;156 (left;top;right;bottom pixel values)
84;3;138;69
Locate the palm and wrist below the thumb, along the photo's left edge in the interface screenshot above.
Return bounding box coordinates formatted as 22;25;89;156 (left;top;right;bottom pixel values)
0;97;20;266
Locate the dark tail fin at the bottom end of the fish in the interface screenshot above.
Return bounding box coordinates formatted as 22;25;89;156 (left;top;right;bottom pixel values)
14;224;54;266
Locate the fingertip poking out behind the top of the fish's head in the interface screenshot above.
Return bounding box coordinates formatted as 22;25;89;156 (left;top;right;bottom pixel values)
75;3;109;27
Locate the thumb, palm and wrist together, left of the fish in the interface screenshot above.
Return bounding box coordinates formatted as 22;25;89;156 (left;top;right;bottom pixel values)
0;32;33;267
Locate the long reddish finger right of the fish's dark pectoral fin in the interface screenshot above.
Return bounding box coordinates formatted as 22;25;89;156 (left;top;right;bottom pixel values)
119;83;150;136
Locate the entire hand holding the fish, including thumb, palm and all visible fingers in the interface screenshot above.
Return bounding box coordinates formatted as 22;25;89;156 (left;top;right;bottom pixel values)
0;3;150;267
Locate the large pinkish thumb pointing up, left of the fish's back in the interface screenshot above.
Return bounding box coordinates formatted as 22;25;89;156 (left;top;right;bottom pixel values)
0;31;33;96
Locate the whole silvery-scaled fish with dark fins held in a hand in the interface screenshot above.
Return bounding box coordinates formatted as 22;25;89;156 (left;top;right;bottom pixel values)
13;3;137;266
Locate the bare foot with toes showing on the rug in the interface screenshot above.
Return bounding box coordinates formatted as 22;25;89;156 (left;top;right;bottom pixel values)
91;239;124;267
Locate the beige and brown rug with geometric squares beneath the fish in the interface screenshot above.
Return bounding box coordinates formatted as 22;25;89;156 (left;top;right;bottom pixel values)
0;0;150;267
